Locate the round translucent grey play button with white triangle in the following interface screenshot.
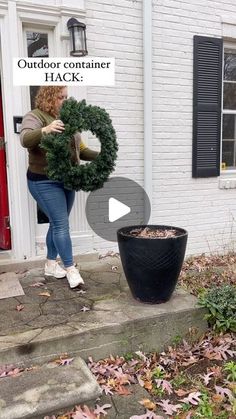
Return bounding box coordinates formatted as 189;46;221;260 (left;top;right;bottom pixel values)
86;176;151;241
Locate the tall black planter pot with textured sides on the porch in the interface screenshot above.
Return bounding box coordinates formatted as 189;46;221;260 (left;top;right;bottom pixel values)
117;225;188;304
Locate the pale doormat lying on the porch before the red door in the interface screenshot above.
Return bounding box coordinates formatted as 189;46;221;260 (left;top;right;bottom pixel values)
0;272;25;300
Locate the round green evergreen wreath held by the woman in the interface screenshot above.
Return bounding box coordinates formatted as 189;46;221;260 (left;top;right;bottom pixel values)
41;98;118;192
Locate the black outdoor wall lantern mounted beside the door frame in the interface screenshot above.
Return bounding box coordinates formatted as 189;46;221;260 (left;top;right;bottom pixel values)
67;17;88;57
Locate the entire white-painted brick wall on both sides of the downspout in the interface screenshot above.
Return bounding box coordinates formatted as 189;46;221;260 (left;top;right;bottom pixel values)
85;0;236;254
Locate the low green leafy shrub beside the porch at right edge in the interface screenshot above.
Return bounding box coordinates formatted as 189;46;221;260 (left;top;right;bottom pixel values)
199;285;236;332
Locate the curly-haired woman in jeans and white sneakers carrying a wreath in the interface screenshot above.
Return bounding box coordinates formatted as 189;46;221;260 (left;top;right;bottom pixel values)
20;86;98;288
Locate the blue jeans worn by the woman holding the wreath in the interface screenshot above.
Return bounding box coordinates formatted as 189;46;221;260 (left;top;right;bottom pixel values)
27;179;75;268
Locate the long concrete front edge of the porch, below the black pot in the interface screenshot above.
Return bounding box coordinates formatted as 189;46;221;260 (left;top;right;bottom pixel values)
0;307;208;365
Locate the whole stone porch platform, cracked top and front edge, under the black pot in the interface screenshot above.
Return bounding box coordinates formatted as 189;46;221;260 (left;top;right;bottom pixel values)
0;257;207;365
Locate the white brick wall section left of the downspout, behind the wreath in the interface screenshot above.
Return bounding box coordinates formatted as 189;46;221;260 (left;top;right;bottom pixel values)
86;0;143;253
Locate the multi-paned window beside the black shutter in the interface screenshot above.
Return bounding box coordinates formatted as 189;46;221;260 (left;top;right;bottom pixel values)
222;47;236;170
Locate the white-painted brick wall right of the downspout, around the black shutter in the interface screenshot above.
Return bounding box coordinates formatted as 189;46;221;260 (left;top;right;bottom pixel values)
153;0;236;254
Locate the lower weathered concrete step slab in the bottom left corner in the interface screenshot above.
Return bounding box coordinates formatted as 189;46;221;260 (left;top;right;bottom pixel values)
0;357;101;419
